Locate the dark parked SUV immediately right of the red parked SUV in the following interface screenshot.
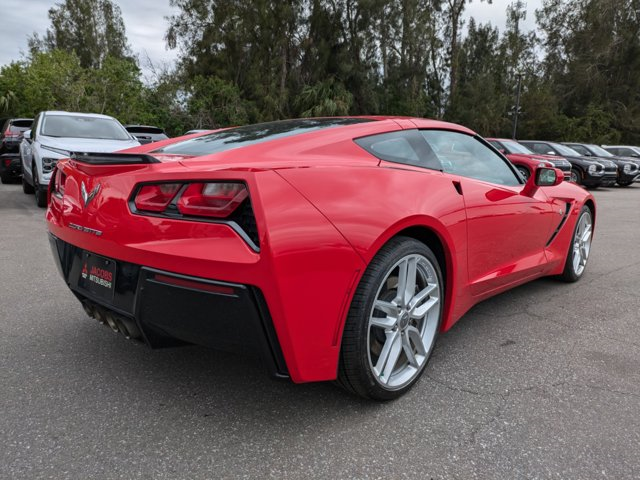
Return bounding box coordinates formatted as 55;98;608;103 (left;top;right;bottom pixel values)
519;140;618;188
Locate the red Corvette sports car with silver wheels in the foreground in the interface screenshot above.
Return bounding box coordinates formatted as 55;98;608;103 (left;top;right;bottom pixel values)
47;117;595;400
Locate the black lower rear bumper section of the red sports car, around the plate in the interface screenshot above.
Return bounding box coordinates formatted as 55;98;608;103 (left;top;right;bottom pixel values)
49;234;288;377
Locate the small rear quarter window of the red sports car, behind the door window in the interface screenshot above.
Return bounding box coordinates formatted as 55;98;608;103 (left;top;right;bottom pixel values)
354;130;442;170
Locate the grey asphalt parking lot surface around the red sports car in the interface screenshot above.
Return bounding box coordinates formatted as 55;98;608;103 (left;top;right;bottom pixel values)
0;181;640;479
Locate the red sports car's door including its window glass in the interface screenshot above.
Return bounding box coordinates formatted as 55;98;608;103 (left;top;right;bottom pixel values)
421;130;555;295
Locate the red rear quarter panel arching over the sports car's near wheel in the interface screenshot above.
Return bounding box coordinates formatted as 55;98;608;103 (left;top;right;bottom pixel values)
278;167;471;331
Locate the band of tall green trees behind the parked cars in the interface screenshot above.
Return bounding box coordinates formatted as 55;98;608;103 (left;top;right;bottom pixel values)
0;0;640;144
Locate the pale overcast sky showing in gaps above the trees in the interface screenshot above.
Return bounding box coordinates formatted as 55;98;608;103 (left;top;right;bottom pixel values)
0;0;542;75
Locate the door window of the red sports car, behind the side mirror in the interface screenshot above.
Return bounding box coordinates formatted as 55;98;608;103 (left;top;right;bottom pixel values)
421;130;521;186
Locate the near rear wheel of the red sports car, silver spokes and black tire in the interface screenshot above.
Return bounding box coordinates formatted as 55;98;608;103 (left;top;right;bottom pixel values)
338;237;445;401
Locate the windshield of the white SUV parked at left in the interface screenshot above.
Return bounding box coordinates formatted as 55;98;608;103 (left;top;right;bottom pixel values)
42;115;131;140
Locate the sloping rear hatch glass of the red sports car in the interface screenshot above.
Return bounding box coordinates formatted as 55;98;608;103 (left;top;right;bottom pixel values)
153;118;372;156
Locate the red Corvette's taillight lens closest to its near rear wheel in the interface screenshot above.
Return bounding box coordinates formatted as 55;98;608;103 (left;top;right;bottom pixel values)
178;182;249;218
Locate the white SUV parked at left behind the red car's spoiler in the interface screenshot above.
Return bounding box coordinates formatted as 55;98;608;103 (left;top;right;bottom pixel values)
20;111;140;207
